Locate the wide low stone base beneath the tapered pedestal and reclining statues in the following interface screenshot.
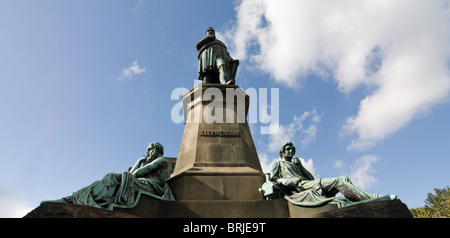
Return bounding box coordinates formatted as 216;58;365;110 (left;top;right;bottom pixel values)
24;195;413;218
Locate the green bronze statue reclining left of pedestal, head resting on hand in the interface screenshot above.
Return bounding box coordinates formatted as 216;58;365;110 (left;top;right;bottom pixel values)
43;142;175;210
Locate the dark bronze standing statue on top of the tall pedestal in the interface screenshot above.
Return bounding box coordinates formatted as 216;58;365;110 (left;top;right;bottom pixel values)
195;27;239;85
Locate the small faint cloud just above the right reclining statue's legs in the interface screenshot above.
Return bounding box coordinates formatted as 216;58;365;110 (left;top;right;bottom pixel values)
349;155;380;189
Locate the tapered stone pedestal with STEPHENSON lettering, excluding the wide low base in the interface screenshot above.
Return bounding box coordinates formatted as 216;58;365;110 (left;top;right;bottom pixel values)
168;84;265;201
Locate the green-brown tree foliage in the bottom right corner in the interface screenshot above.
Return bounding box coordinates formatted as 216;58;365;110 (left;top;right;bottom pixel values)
410;186;450;218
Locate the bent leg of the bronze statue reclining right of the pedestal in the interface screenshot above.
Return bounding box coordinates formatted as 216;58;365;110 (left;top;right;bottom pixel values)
320;176;377;202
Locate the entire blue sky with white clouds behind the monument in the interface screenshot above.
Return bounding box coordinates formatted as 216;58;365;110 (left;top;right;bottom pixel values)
0;0;450;217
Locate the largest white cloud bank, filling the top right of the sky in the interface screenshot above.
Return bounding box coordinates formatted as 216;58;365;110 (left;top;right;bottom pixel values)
223;0;450;149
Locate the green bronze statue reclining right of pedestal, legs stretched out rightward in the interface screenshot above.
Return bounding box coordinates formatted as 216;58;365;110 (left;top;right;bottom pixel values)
260;142;396;208
